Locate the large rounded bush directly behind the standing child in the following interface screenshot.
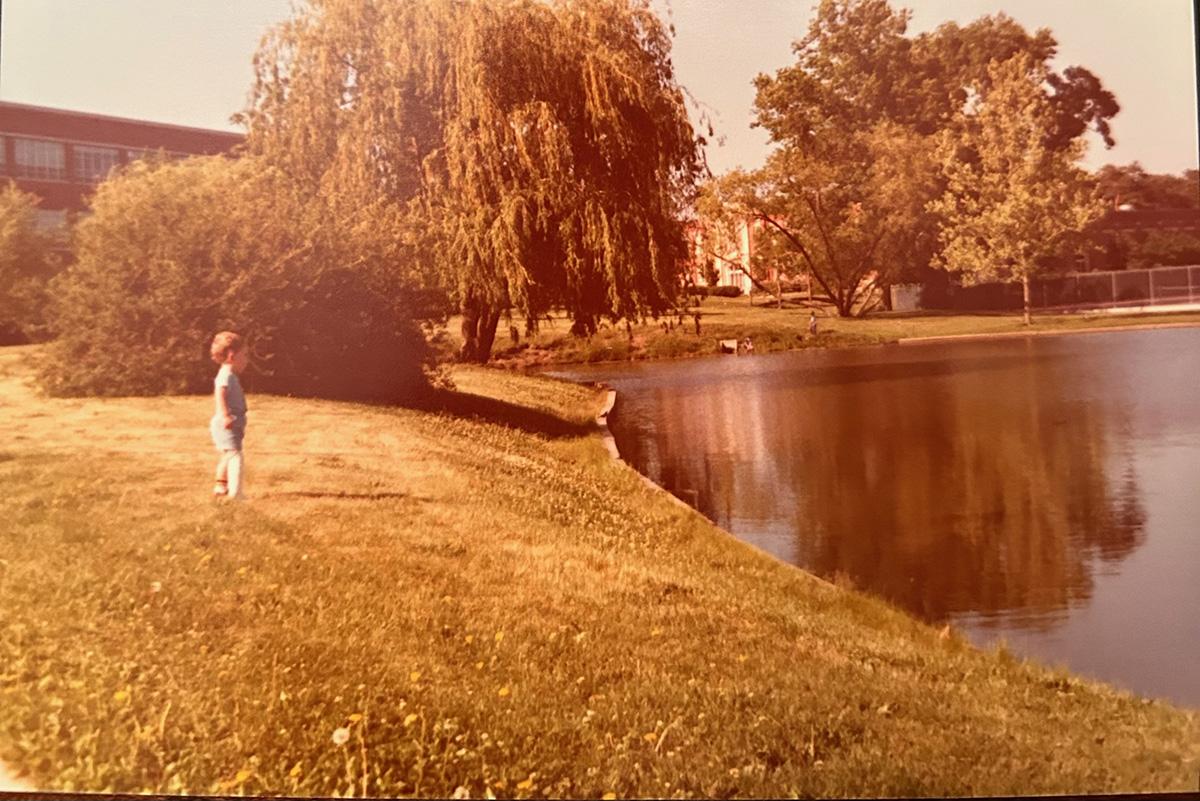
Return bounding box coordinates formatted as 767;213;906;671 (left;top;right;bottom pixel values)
41;157;426;401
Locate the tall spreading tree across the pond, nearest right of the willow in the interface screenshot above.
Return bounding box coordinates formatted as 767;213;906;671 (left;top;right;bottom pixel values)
743;0;937;315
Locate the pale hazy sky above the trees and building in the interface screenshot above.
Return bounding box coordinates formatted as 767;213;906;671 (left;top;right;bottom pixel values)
0;0;1198;173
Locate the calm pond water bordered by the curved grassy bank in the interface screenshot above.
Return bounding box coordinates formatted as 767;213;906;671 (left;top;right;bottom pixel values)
556;329;1200;706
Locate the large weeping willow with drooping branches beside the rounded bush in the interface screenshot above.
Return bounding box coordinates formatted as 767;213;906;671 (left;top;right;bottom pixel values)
242;0;703;361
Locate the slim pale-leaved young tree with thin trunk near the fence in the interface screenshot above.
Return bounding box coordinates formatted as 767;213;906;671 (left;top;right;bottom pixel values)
930;54;1103;324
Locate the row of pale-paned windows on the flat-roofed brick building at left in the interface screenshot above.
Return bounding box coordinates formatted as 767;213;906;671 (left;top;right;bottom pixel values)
0;137;187;183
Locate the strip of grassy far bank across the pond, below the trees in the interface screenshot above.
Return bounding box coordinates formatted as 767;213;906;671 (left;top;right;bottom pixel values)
470;297;1200;367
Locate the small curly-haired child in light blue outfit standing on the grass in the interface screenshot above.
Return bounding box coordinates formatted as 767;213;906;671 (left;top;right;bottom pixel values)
209;331;250;500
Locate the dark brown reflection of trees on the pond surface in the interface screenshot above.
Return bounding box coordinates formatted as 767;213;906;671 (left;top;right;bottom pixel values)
617;343;1146;628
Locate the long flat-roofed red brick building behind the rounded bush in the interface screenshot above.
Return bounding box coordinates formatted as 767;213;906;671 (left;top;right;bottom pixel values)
0;101;242;228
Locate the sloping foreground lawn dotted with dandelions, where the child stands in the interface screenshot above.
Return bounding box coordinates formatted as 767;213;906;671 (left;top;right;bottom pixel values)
0;349;1200;797
